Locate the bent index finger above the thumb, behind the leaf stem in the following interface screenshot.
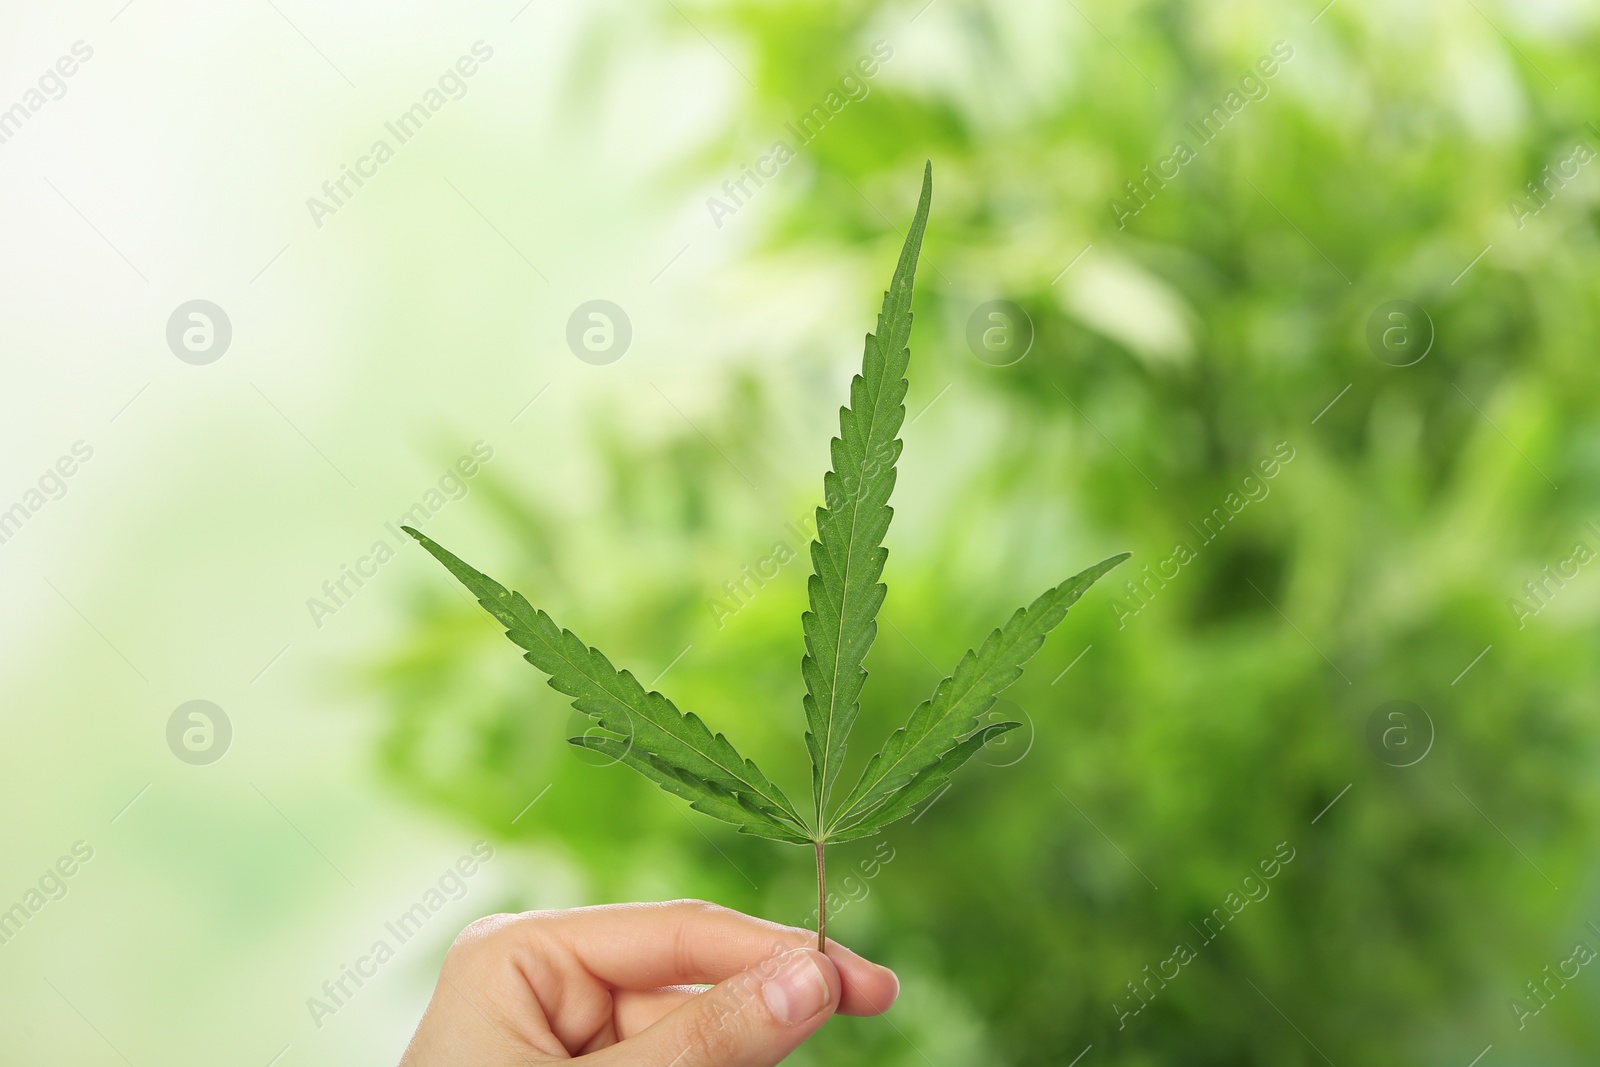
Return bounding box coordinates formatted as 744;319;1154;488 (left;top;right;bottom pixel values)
507;901;899;1016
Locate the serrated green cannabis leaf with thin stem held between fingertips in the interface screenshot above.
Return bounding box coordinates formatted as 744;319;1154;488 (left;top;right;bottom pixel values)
403;163;1128;949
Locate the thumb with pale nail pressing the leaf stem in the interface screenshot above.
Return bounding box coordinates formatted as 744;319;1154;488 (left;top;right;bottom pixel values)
586;949;840;1067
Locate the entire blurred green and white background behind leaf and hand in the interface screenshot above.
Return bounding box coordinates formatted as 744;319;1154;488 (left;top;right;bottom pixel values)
0;0;1600;1067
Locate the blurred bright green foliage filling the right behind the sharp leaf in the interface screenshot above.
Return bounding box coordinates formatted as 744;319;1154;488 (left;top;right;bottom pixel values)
368;0;1600;1067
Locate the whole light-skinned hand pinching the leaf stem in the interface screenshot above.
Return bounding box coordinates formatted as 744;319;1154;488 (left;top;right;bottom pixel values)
400;901;899;1067
